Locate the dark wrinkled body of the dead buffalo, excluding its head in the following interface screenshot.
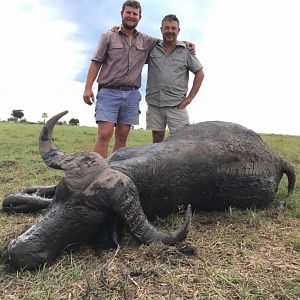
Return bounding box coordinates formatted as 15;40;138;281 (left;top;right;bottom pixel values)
112;121;295;216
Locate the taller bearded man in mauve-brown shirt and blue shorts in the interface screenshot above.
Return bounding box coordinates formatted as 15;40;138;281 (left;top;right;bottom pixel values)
83;0;158;158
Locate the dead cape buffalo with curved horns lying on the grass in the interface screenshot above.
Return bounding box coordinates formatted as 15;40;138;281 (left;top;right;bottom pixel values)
3;112;295;269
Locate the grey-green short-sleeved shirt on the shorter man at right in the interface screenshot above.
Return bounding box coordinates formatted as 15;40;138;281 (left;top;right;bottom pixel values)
146;41;202;107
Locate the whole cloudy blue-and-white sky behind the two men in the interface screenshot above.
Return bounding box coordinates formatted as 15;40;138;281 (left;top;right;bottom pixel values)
0;0;300;135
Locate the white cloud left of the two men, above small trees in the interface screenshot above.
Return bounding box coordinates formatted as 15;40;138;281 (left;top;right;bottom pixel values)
0;1;94;124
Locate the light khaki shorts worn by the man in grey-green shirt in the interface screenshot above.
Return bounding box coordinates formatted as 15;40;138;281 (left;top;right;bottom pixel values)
146;104;190;134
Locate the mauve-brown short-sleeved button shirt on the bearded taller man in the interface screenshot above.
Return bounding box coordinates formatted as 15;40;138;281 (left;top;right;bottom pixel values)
92;31;159;88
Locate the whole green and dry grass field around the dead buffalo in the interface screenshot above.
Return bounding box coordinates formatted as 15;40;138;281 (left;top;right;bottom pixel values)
0;123;300;300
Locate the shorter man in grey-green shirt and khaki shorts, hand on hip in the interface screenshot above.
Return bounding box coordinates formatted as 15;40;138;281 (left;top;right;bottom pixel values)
146;15;204;143
